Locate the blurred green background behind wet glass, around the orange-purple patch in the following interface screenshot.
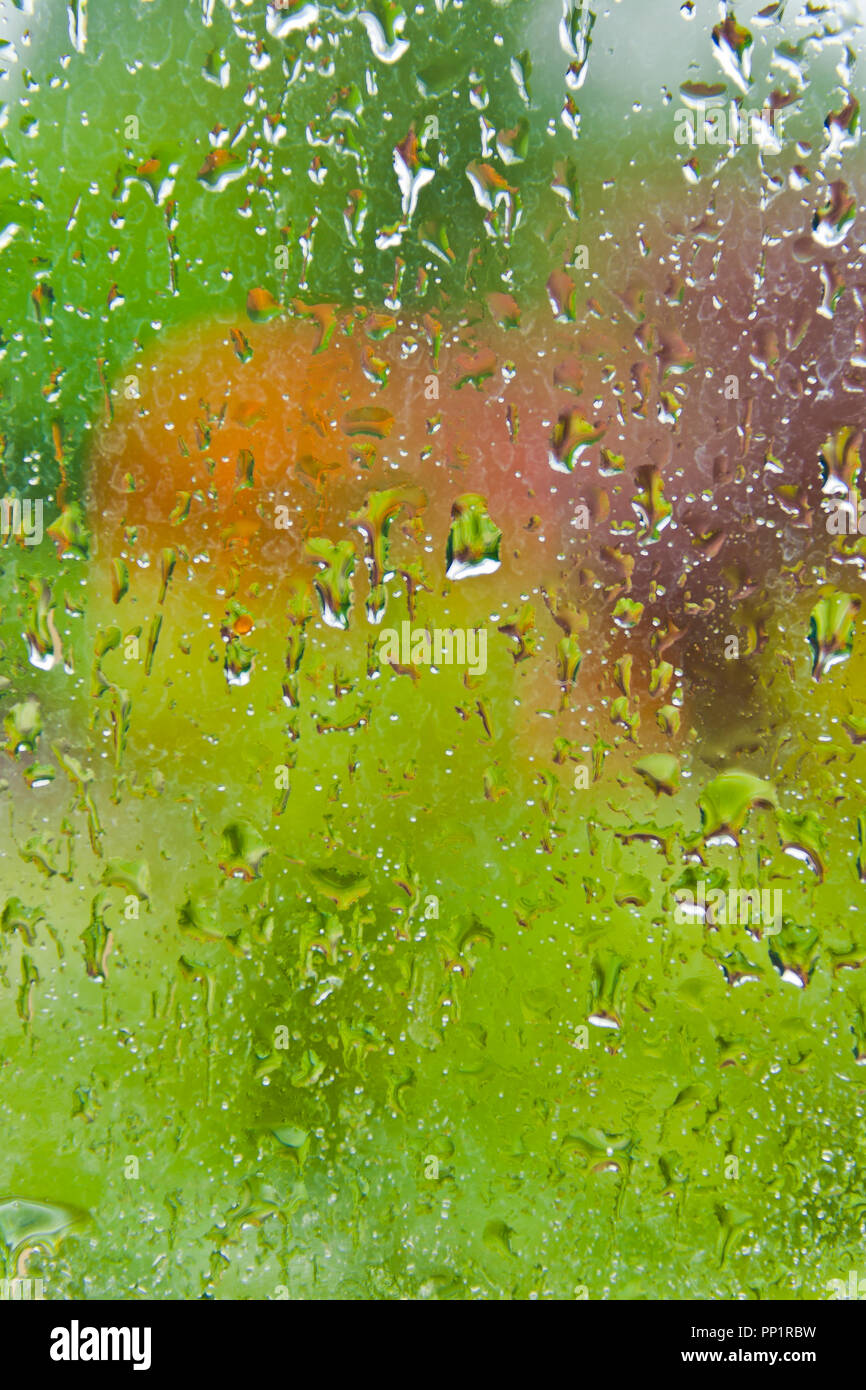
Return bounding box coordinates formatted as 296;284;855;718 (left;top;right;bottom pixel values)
0;0;866;1298
